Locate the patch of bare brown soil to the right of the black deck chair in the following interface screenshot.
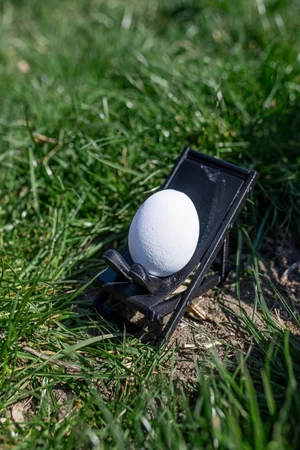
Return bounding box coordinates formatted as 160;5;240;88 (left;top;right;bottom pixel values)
166;236;300;380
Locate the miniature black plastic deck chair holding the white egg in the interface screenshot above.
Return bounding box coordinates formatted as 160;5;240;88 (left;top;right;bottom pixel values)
94;147;257;346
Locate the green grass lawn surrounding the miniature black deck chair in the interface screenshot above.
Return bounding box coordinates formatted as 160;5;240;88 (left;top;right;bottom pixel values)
0;0;300;450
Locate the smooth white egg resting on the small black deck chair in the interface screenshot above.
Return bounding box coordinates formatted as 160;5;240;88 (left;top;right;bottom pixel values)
128;189;200;277
